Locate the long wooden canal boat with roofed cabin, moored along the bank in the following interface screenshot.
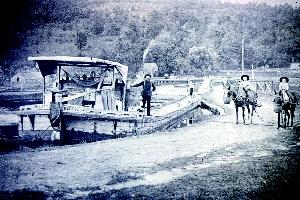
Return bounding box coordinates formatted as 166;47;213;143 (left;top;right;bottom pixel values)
17;56;219;142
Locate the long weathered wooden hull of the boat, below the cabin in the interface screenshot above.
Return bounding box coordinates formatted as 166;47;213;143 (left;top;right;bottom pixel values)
15;98;219;144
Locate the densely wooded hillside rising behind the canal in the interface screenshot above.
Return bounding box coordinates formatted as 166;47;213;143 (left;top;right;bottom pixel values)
0;0;300;81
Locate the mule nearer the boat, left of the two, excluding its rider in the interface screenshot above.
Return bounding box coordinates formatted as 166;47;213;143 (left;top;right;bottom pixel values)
225;86;257;124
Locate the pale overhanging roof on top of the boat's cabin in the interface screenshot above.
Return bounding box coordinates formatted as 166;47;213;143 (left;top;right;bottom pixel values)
28;56;128;82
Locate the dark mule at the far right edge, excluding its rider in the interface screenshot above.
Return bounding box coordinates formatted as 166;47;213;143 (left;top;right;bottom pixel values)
273;91;298;129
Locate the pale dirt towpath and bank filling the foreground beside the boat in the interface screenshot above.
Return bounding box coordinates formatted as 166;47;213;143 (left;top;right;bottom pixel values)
0;93;300;199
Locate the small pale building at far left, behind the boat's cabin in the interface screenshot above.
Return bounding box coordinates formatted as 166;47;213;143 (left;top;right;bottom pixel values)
10;72;43;88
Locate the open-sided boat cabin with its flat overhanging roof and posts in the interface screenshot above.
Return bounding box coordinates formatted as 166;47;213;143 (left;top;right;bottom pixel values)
28;56;128;111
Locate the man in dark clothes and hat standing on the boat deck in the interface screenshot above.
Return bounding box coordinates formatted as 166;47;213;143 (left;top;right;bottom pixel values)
131;74;156;116
